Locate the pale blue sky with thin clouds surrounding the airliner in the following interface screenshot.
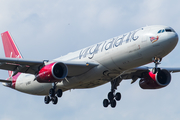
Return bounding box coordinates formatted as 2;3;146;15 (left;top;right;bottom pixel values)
0;0;180;120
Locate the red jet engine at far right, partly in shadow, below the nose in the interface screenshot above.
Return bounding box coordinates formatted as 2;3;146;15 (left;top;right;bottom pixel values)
139;69;171;89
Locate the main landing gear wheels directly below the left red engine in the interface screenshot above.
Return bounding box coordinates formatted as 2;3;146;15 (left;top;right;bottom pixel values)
44;83;63;105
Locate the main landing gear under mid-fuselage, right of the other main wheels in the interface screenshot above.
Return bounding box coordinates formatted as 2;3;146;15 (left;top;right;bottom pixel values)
103;77;122;108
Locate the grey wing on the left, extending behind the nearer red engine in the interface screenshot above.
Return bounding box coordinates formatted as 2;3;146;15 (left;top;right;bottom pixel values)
0;58;98;76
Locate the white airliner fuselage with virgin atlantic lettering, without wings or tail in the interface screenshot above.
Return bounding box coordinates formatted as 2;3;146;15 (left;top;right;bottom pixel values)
10;26;178;95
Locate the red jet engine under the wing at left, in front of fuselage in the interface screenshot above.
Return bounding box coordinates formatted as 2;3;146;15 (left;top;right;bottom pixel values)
36;62;68;83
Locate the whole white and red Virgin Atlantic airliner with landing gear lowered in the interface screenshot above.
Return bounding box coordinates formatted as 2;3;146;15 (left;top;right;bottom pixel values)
0;25;180;108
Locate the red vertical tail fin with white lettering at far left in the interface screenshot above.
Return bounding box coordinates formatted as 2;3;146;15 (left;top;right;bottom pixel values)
1;31;22;76
